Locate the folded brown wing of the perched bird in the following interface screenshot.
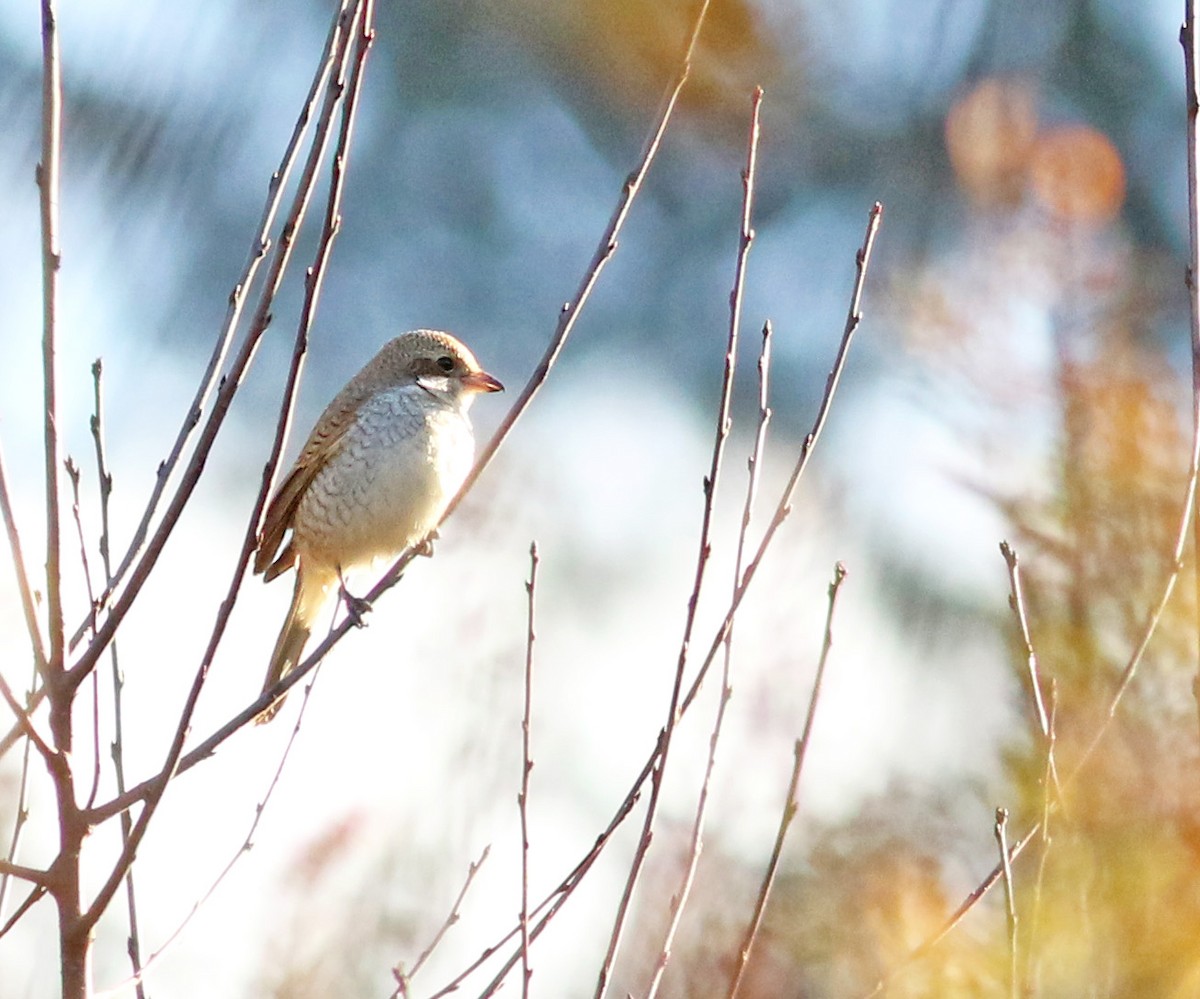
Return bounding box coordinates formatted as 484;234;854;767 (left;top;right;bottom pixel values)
254;382;371;580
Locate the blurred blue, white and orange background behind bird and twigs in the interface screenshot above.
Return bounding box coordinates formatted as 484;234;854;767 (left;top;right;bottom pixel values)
0;0;1200;997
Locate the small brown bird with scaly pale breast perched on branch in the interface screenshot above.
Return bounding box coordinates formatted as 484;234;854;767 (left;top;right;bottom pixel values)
254;329;504;724
